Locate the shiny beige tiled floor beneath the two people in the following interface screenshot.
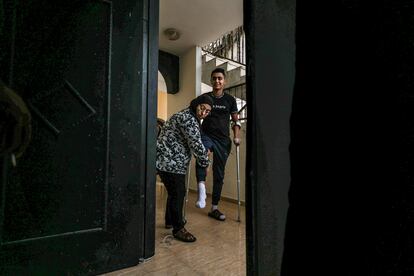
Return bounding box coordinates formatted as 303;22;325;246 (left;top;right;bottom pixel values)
105;183;246;276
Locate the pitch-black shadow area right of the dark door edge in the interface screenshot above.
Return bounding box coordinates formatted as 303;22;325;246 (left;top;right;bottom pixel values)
282;1;414;275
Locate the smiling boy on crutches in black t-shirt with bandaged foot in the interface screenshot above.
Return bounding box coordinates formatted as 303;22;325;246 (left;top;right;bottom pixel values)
196;68;241;221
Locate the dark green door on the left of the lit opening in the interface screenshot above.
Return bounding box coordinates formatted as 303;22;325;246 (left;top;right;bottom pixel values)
0;0;158;275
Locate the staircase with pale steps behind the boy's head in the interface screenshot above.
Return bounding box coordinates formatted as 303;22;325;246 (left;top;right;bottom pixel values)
201;51;246;100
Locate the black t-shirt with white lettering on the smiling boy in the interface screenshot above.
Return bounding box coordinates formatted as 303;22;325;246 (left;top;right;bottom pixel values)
201;92;237;139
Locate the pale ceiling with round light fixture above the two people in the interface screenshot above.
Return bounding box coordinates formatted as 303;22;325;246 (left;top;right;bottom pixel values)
159;0;243;56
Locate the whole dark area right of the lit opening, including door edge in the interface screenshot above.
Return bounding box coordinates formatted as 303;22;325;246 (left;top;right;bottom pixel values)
245;0;414;276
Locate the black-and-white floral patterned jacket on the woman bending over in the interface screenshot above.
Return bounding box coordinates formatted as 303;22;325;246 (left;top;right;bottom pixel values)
156;108;209;174
